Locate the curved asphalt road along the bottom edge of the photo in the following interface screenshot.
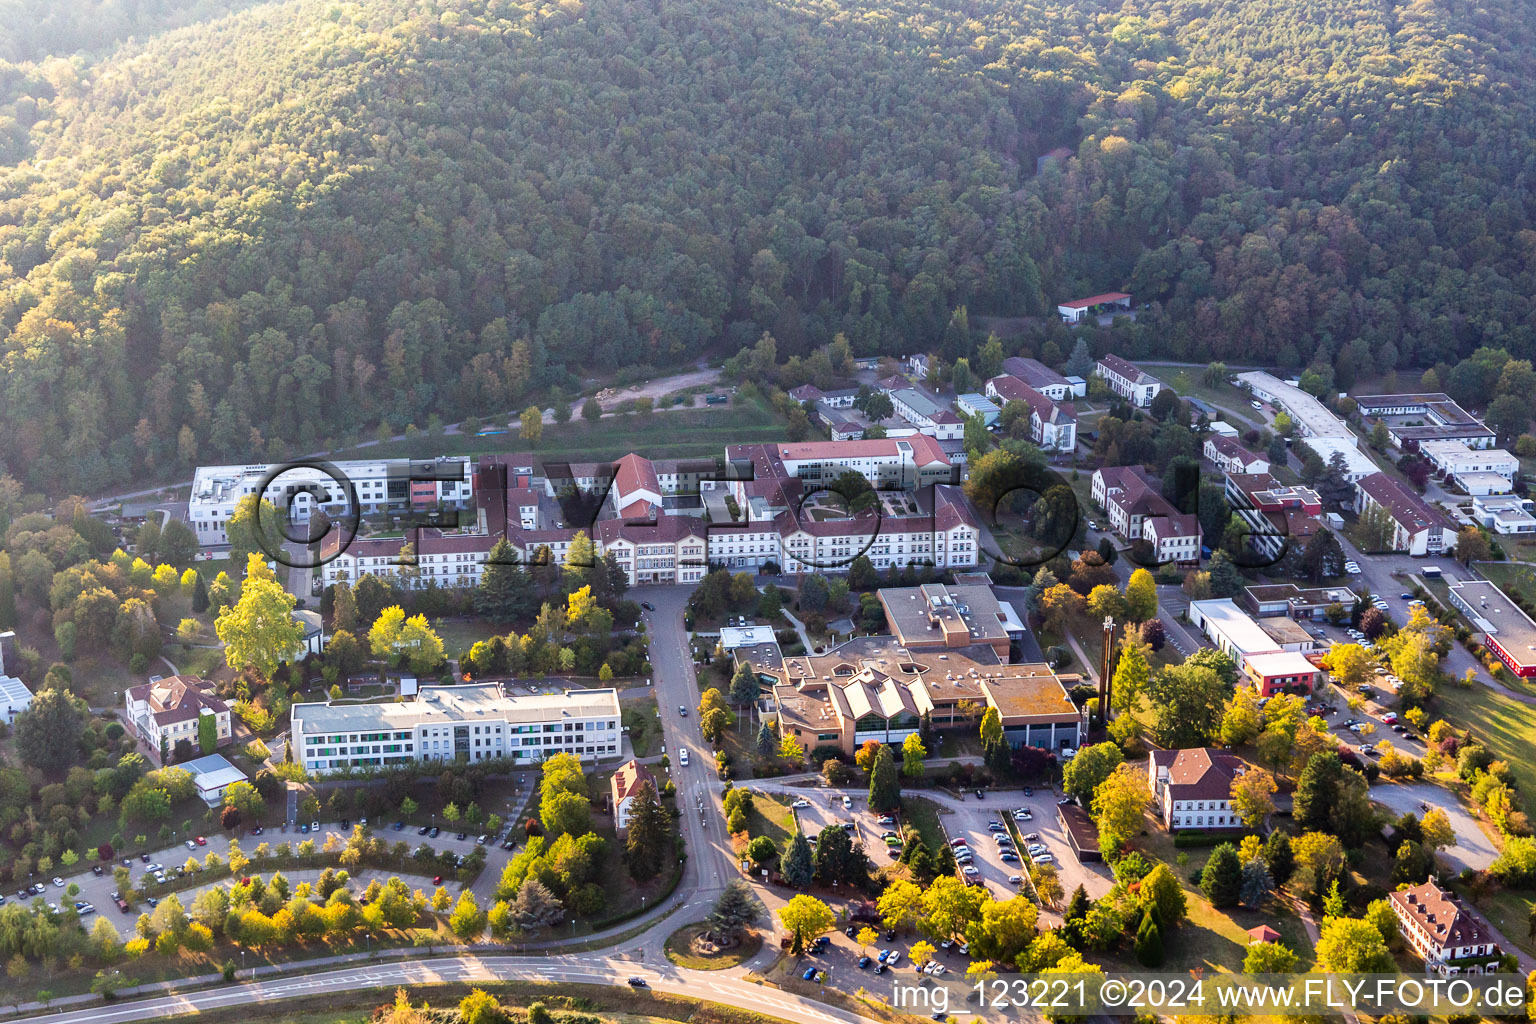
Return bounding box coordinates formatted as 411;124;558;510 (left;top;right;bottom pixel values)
38;953;863;1024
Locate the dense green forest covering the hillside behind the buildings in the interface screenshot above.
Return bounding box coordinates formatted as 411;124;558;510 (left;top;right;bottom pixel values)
0;0;1536;493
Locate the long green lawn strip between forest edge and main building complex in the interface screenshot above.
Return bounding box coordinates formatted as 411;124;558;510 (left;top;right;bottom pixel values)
322;398;783;462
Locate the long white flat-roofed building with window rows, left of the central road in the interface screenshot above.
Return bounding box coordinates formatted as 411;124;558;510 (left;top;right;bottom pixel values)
290;683;622;774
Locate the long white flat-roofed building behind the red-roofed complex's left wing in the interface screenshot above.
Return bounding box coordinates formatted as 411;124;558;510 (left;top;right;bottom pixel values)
187;456;475;545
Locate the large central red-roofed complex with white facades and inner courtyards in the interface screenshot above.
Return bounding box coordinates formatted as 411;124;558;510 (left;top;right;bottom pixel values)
321;434;980;588
